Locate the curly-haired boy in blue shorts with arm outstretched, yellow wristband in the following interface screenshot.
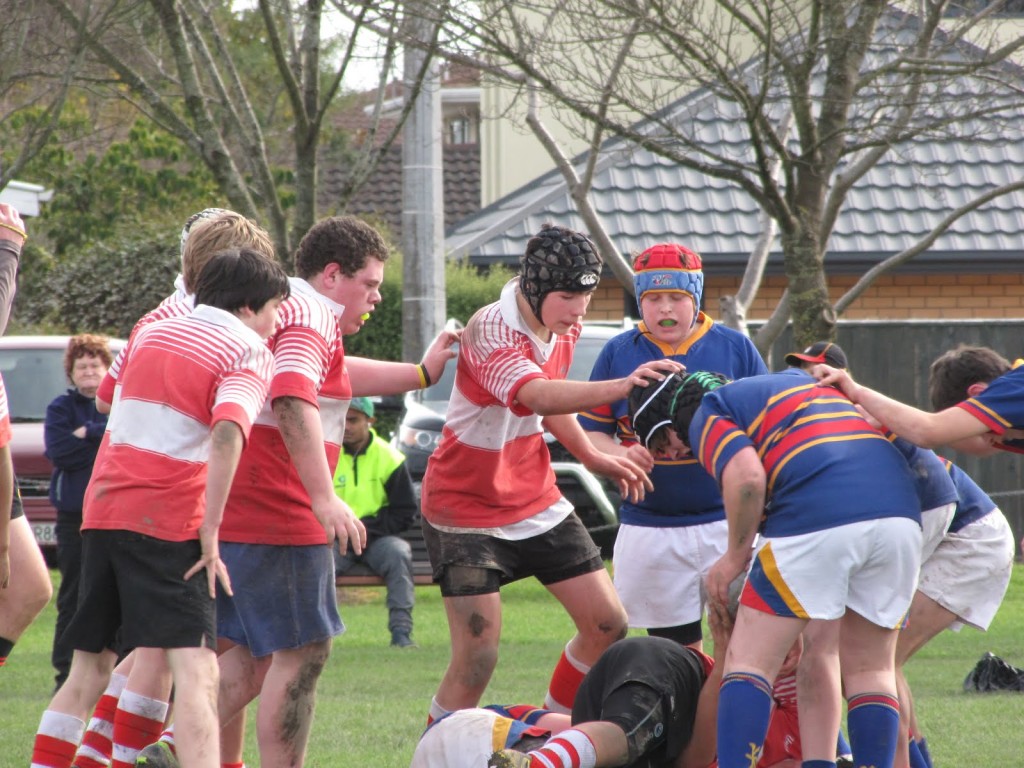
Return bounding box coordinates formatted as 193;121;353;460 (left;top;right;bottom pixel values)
211;216;451;765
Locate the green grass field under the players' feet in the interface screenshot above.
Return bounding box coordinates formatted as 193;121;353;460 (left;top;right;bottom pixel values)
0;565;1024;768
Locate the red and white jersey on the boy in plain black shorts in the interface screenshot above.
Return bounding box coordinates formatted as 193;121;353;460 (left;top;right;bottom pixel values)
82;306;273;541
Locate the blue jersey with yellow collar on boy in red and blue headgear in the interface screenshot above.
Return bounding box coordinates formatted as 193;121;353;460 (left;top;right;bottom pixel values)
578;312;768;527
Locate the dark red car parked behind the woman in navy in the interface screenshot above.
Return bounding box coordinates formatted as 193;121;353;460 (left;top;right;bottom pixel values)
0;336;125;562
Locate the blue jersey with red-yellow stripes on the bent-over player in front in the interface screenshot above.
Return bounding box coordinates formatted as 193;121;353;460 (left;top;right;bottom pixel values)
689;369;921;537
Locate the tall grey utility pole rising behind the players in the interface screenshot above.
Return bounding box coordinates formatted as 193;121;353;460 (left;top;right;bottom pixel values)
401;0;446;360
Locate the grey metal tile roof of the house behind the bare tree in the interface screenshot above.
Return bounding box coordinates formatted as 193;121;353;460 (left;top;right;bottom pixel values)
445;19;1024;272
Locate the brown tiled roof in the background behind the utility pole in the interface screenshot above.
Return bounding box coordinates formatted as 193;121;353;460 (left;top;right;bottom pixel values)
319;144;480;241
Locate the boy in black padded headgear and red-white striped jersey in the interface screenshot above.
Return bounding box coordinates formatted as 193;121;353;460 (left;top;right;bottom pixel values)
423;224;682;719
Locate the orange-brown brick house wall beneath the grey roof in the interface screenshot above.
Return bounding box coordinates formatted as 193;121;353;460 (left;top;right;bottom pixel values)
587;273;1024;321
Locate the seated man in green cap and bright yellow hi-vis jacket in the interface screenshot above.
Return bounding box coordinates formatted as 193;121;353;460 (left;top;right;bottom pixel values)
334;397;417;648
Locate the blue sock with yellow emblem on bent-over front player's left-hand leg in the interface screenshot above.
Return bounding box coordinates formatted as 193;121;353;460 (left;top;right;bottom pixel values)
718;672;771;768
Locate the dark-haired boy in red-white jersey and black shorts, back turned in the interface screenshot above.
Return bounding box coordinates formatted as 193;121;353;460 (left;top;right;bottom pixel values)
33;249;289;768
